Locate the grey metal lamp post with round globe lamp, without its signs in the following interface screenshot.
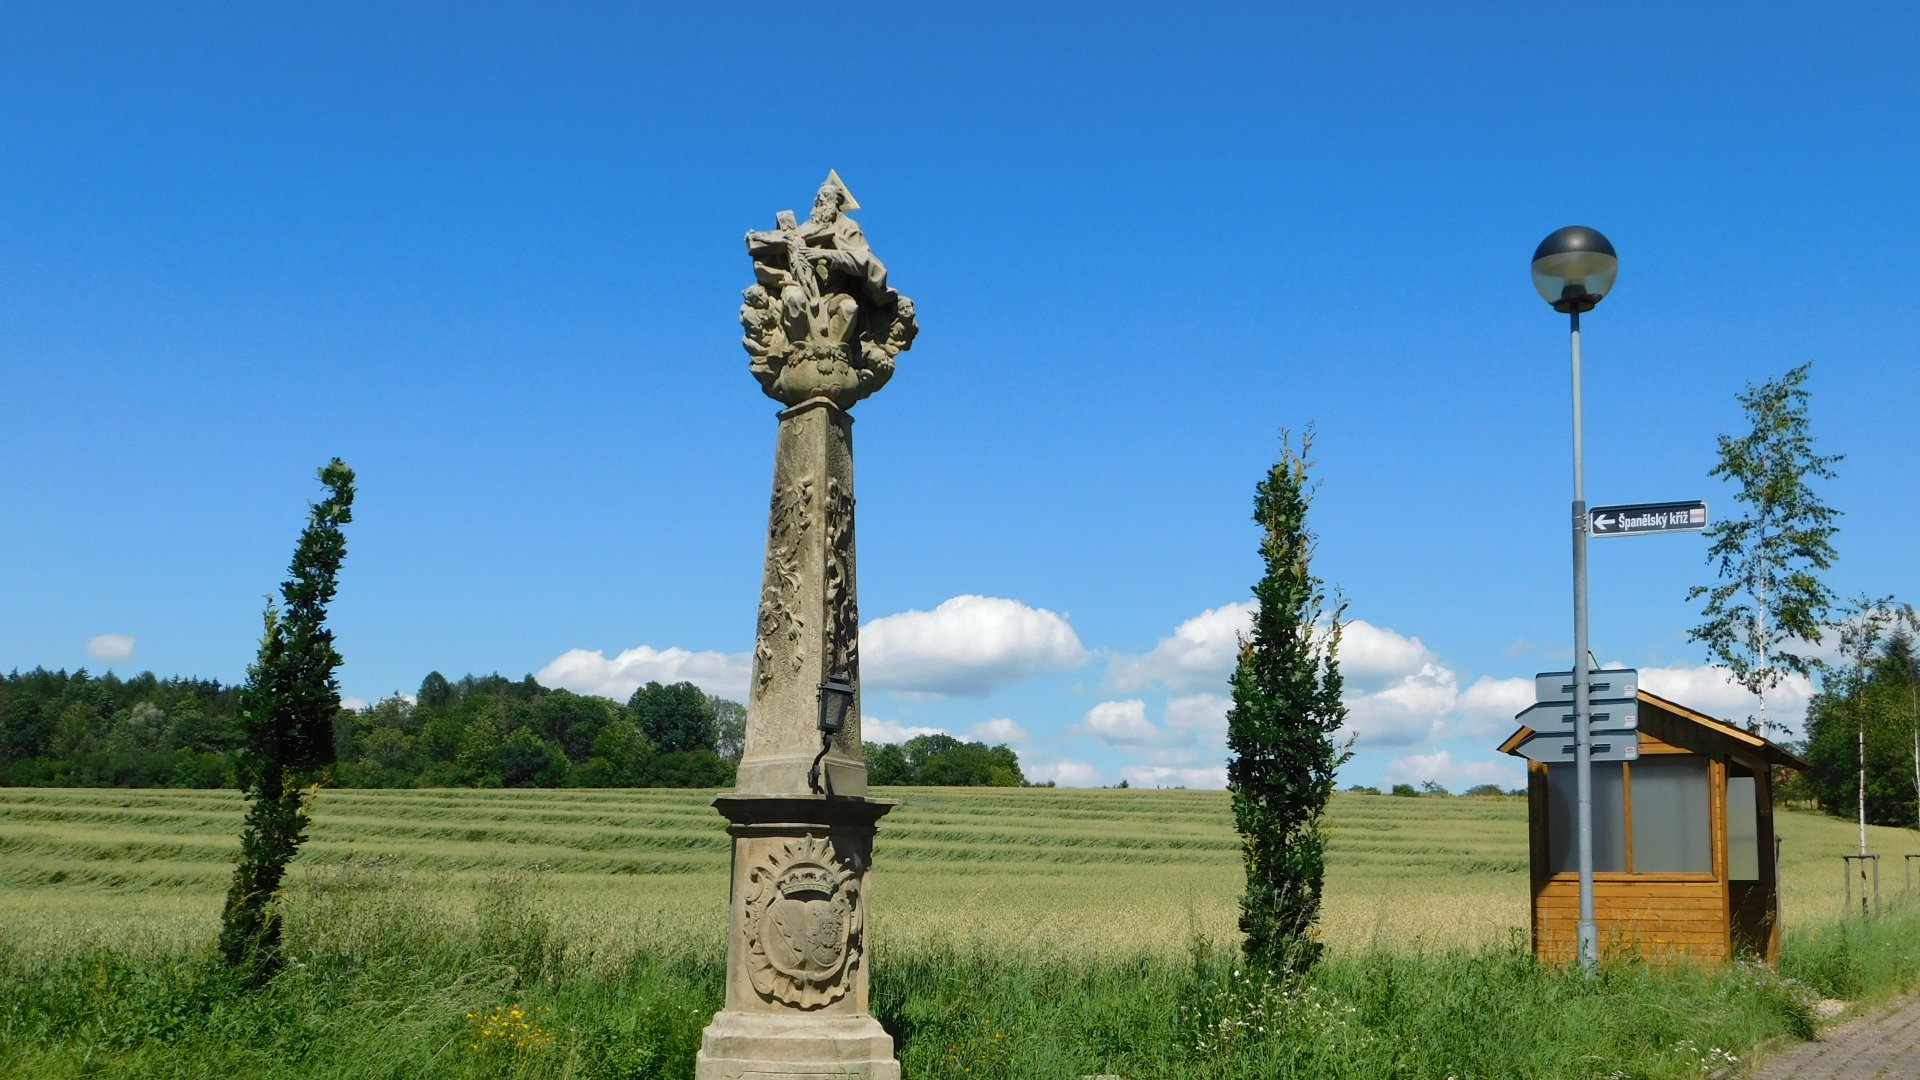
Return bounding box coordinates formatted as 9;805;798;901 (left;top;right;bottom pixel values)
1534;225;1620;970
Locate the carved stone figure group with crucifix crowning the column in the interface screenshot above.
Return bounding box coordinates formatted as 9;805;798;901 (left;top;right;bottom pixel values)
739;171;920;409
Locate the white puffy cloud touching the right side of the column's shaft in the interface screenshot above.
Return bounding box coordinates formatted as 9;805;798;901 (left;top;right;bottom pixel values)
860;596;1087;698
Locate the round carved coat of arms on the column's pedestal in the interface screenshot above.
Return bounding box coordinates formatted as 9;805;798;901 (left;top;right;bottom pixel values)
743;836;864;1009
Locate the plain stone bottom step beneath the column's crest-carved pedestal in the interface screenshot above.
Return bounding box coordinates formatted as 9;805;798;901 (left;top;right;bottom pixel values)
693;1009;900;1080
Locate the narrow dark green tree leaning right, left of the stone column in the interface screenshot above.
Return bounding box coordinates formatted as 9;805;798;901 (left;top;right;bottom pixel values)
221;457;353;984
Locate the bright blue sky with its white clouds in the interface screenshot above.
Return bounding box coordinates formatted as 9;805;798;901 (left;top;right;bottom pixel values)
0;4;1920;788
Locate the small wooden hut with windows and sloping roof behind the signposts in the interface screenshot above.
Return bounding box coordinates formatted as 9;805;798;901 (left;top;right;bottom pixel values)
1500;690;1807;963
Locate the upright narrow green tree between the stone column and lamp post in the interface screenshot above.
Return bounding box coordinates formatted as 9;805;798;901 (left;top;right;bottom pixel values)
1227;430;1350;974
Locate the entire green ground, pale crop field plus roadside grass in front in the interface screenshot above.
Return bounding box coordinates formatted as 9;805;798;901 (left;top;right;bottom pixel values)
0;788;1920;1080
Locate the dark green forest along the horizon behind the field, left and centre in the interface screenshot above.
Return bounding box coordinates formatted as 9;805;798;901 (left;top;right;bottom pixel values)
0;669;1025;788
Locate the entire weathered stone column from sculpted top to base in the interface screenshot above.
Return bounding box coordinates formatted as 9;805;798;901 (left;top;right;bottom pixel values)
695;173;918;1080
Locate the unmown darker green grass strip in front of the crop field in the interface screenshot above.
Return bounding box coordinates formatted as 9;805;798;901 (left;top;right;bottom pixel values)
0;849;1920;1080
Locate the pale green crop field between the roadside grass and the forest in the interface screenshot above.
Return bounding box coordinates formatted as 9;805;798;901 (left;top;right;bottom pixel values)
0;776;1920;955
